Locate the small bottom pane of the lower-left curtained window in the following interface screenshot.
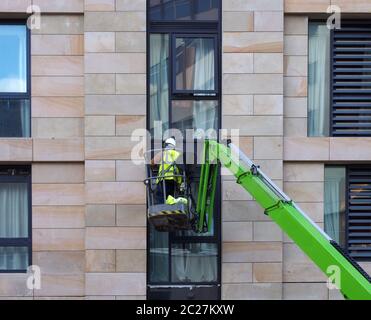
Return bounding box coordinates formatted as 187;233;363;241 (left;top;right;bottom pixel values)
0;247;28;271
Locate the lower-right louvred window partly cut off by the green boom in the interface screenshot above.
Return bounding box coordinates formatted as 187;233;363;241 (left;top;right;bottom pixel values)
324;165;371;261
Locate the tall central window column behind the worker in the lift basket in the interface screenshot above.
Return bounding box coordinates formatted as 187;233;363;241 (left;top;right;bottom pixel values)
147;0;221;298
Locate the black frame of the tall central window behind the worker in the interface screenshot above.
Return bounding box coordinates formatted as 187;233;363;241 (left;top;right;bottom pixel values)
146;1;222;298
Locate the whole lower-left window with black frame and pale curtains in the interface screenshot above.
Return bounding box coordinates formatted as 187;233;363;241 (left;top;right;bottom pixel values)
0;166;32;272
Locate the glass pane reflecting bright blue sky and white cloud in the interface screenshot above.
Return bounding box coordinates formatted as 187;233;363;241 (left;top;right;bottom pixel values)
0;25;27;93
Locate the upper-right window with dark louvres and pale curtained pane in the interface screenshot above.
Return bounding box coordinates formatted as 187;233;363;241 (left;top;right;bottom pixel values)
308;20;371;137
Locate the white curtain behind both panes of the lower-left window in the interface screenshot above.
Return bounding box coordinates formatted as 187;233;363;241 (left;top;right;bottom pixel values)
0;183;28;270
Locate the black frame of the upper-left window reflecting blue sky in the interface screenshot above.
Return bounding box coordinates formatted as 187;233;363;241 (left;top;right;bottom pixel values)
0;19;32;139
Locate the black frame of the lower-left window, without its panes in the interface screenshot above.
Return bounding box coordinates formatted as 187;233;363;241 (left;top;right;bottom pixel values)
0;165;32;274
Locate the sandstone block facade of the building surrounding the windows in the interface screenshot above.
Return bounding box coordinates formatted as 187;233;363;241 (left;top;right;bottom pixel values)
0;0;371;300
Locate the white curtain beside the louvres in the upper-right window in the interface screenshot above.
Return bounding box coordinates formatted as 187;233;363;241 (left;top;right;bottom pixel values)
308;23;330;137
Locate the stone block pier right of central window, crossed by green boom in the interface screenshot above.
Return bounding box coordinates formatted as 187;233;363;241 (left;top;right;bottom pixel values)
222;0;284;300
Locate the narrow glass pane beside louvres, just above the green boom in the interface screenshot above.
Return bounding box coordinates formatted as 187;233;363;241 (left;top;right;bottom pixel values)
324;167;346;246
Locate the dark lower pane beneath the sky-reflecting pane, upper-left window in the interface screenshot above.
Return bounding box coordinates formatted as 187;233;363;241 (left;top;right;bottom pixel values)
0;100;31;138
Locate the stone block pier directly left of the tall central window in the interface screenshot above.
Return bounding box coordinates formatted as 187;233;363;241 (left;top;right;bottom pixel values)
85;0;146;299
